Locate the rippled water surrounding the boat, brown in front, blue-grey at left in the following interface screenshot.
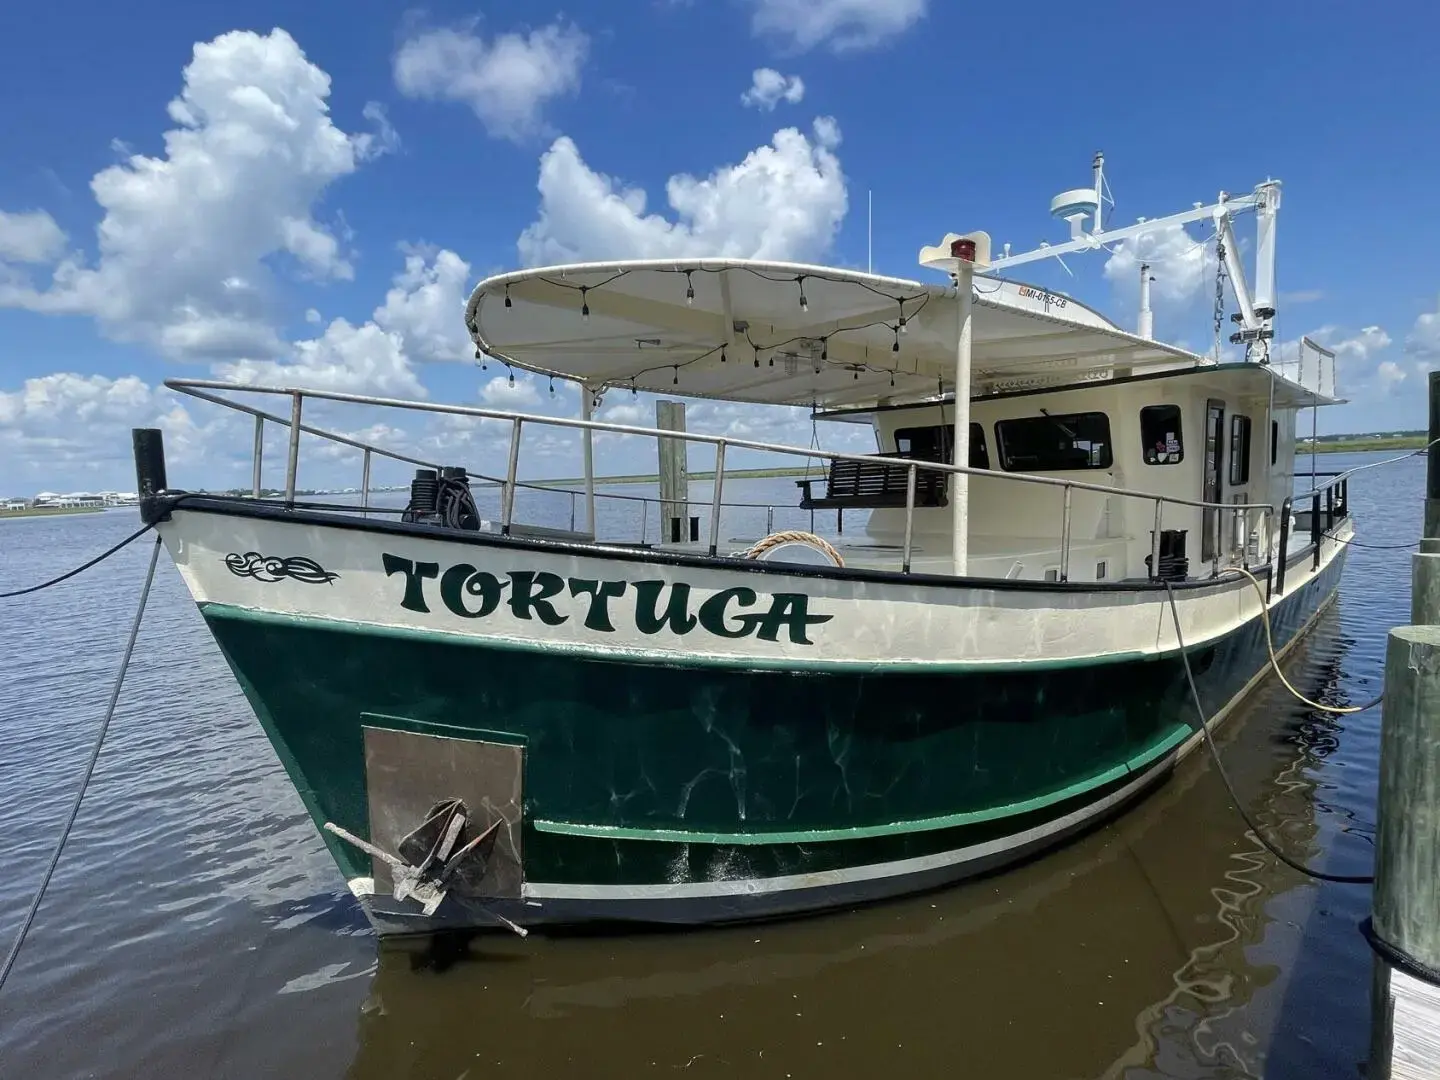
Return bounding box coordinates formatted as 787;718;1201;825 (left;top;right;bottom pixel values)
0;455;1405;1080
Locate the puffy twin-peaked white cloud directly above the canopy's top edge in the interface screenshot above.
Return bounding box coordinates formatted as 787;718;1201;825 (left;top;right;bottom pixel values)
518;117;847;266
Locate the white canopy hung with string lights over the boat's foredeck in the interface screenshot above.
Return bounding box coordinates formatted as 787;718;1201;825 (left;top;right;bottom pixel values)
465;259;1226;409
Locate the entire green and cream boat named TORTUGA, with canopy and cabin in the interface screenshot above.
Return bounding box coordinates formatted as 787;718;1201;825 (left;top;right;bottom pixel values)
137;160;1352;933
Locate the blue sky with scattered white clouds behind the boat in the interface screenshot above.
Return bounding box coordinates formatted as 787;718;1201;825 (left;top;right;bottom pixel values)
0;0;1440;494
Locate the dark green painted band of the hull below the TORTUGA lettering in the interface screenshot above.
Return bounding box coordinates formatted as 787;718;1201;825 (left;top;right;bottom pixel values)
194;560;1339;884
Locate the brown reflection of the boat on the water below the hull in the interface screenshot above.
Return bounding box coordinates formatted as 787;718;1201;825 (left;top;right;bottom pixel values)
348;613;1344;1080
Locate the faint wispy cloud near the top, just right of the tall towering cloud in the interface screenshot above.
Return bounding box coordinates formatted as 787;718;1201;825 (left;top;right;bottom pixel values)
395;22;590;140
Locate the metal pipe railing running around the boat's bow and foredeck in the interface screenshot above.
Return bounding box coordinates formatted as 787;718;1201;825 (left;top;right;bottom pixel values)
166;379;1283;582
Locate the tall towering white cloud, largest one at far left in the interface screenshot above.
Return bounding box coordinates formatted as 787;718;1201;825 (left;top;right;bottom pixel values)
0;29;393;359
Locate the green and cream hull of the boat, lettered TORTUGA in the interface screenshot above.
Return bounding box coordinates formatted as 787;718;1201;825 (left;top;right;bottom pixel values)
160;507;1345;933
